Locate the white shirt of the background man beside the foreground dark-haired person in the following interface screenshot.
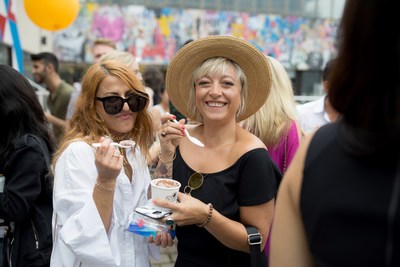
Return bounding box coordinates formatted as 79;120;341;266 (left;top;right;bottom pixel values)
297;95;331;134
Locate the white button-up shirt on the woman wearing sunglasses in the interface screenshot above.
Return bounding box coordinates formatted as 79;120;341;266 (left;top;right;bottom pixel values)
51;141;159;267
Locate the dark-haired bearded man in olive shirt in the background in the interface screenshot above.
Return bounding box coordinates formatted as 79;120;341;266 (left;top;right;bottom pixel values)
31;52;74;142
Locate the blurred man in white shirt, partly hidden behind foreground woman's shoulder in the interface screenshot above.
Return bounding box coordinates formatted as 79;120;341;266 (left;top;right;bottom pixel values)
297;59;339;134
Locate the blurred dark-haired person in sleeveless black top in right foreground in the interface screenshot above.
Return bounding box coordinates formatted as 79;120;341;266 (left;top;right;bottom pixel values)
270;0;400;267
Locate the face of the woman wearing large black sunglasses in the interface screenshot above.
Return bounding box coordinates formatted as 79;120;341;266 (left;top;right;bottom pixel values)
96;75;138;135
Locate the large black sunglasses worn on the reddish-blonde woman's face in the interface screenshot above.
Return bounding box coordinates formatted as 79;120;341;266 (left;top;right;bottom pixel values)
96;95;148;115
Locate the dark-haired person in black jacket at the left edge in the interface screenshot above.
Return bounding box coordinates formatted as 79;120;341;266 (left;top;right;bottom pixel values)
0;65;54;267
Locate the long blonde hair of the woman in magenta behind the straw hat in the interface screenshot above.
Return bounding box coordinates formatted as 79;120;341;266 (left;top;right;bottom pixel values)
241;57;298;148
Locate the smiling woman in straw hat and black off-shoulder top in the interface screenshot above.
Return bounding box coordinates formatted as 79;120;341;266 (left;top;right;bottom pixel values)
153;36;281;266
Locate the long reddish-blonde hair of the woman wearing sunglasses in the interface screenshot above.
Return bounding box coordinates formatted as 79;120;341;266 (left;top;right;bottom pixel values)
53;60;153;163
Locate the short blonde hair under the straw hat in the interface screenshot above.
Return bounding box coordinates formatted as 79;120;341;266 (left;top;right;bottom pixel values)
188;57;248;123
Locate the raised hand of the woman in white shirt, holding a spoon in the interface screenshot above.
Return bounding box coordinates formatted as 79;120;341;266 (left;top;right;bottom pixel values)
95;137;124;182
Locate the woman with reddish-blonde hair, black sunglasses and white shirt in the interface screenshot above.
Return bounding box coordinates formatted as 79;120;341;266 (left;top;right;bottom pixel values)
51;61;172;267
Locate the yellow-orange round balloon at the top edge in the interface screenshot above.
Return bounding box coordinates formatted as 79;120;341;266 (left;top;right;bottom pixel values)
24;0;79;31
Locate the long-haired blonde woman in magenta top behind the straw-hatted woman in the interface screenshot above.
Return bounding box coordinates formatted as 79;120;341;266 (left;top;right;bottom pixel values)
241;57;302;174
